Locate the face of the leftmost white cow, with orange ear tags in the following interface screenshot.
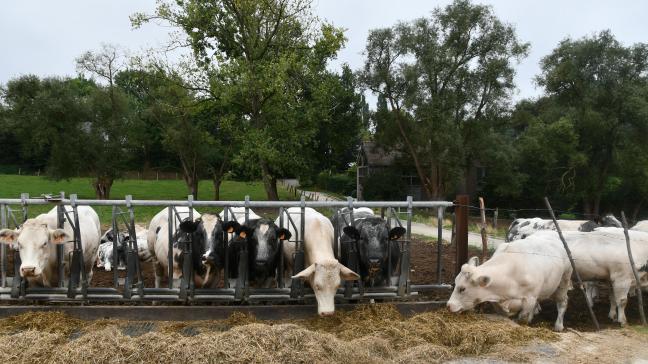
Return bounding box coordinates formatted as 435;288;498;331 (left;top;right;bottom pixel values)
0;219;71;278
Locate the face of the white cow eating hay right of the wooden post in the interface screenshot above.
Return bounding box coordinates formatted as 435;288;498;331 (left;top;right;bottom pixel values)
447;258;499;312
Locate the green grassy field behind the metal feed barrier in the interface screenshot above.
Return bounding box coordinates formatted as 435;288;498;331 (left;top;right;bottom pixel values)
0;174;291;225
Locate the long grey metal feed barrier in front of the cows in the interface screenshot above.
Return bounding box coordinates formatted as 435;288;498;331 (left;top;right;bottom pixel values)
0;193;454;303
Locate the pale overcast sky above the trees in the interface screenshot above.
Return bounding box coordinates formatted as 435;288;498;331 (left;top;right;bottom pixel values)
0;0;648;102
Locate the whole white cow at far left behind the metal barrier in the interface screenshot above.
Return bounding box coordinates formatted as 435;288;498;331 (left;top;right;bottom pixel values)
0;206;101;287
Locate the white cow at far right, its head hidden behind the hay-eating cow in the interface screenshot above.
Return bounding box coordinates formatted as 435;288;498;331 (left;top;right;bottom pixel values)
560;227;648;325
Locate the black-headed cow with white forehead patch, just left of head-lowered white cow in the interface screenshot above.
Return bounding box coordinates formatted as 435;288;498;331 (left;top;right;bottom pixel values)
225;218;291;288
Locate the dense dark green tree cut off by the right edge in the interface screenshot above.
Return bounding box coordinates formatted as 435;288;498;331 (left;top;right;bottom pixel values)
537;31;648;215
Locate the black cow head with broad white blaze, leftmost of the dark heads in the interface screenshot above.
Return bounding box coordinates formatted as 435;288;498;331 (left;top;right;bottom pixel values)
174;214;225;287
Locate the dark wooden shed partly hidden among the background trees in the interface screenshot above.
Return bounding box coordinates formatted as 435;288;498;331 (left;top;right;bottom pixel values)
356;141;486;200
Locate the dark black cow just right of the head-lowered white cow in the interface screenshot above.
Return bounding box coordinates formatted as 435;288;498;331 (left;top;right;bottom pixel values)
332;208;406;287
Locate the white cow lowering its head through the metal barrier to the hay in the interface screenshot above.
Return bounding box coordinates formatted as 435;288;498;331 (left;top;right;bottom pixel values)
275;207;360;316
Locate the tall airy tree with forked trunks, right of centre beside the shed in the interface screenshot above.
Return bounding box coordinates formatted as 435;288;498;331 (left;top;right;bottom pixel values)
361;0;528;199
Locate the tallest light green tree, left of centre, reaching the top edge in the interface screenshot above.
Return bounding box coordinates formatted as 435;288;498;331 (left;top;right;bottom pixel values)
132;0;344;200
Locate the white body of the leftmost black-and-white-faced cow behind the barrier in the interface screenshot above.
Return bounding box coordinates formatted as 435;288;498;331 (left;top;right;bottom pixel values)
147;206;200;288
